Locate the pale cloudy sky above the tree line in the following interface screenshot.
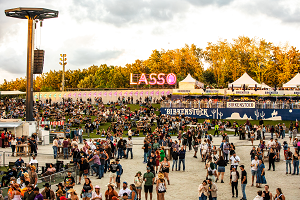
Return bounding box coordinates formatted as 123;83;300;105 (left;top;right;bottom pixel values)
0;0;300;83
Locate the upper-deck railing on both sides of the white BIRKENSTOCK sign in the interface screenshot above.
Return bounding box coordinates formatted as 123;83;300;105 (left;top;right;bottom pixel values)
160;101;300;109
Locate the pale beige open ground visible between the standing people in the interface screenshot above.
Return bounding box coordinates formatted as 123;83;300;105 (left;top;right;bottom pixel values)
0;134;300;200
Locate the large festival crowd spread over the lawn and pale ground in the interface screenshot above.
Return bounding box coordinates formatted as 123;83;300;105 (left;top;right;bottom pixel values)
1;95;300;200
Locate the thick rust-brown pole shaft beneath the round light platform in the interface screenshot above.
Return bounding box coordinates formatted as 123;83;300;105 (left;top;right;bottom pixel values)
26;16;35;121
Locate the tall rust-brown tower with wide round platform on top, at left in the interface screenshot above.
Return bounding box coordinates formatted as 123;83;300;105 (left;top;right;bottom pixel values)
4;8;58;121
